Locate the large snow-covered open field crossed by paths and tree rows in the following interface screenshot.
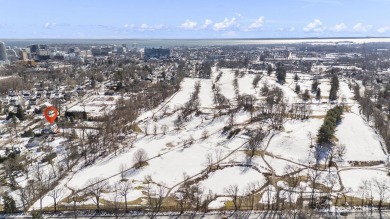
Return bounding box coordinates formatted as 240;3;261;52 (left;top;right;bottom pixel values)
4;68;386;212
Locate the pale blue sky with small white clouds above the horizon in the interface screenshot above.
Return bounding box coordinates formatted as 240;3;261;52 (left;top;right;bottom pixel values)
0;0;390;38
